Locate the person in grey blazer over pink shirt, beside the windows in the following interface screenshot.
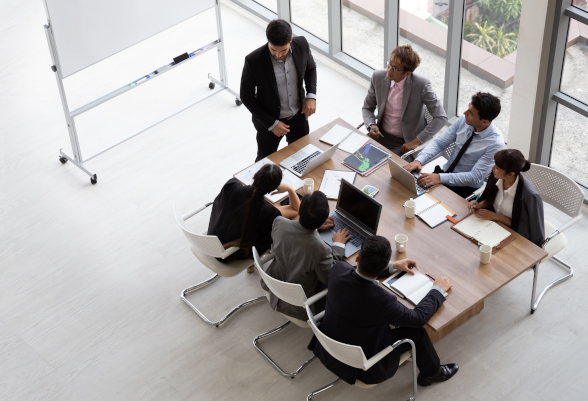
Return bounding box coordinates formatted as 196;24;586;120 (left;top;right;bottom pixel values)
362;45;447;156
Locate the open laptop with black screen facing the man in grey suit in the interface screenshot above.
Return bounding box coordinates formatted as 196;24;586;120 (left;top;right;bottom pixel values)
319;179;382;258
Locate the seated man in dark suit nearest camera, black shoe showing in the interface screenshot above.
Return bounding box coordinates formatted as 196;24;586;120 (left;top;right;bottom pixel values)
308;235;459;386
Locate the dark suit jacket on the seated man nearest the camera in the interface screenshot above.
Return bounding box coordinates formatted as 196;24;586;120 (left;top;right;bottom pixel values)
308;262;445;384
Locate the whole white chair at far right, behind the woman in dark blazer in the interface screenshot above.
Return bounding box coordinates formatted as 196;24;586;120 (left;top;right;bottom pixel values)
522;163;584;313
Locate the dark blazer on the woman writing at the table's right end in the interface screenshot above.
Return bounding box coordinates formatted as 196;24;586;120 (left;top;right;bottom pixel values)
480;174;545;246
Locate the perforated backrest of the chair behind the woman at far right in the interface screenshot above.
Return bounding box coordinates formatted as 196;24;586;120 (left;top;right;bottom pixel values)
522;163;584;217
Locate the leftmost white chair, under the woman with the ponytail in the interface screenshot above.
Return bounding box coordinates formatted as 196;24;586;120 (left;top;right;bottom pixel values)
174;202;266;327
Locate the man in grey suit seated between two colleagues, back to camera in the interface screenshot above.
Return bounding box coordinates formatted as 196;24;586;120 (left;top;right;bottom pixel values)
261;191;351;321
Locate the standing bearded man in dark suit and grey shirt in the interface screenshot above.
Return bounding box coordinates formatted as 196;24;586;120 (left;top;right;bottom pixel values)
240;19;316;161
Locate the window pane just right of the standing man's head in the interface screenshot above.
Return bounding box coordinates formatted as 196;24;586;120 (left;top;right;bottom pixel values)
290;0;329;42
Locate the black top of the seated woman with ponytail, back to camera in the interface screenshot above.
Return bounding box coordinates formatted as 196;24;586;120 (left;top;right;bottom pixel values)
208;178;281;263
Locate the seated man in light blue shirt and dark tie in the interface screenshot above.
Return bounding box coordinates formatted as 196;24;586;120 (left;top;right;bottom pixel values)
404;92;505;198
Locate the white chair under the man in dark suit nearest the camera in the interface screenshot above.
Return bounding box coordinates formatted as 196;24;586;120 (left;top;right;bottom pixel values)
305;290;417;401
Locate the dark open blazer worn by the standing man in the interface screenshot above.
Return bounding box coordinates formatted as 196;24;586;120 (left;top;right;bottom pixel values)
239;36;316;131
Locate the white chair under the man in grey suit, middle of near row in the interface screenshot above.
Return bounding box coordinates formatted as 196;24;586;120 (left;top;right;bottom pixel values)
253;247;320;379
